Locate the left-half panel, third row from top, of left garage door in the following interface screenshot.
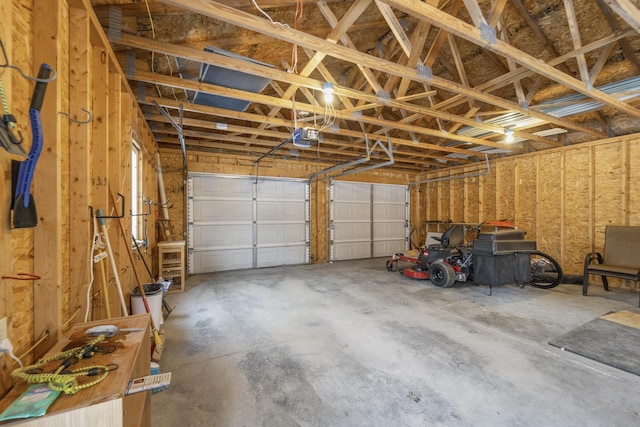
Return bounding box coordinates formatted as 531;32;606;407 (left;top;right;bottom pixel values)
193;224;253;249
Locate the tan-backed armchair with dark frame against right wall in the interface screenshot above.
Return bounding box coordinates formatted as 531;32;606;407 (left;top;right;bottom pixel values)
582;225;640;305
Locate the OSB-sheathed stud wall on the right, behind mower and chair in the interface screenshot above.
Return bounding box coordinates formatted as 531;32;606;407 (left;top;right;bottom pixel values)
418;135;640;284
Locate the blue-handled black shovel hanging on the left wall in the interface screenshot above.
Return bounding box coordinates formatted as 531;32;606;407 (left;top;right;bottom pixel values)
13;64;53;228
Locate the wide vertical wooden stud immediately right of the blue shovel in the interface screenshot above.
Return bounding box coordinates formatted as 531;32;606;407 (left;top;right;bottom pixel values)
31;0;63;359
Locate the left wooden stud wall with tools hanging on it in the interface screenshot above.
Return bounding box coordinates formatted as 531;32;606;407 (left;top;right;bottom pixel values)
0;0;157;394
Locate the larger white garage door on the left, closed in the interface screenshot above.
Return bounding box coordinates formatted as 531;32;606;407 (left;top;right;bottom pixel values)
187;174;309;274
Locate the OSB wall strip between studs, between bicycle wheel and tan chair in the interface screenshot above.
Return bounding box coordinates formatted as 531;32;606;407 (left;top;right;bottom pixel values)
562;149;592;272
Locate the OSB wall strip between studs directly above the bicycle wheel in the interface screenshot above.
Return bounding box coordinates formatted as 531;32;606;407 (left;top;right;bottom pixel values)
536;152;563;259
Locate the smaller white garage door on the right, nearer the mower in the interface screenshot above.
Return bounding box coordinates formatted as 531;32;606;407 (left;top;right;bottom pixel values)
329;181;409;261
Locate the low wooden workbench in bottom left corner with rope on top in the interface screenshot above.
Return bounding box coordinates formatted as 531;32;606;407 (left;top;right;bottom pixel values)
0;314;151;427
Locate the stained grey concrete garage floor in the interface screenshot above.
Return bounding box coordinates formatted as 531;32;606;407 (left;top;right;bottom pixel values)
152;259;640;427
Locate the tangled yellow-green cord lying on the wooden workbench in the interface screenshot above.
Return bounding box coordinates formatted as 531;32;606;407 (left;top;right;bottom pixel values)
11;335;111;394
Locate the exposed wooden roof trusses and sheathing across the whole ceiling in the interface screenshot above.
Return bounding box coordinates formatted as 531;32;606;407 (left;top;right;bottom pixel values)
92;0;640;173
